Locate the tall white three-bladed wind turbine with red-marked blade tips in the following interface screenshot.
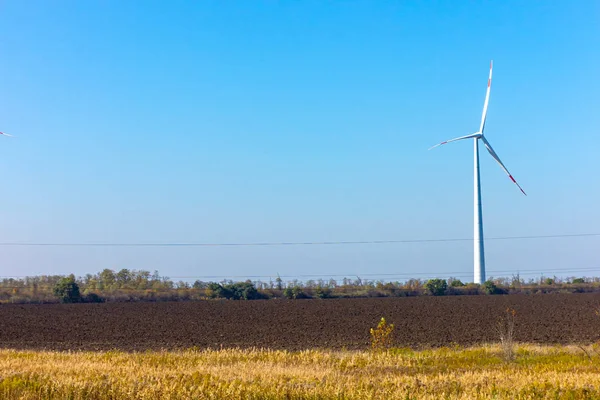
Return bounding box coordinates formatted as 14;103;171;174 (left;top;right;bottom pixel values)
429;61;527;284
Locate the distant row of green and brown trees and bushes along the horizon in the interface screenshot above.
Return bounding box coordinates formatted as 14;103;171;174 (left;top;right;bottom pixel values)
0;269;600;303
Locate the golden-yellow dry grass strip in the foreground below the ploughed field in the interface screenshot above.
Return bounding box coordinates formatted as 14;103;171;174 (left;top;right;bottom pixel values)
0;345;600;400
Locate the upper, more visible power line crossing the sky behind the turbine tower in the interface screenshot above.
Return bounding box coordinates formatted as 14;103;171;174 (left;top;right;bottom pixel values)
0;233;600;247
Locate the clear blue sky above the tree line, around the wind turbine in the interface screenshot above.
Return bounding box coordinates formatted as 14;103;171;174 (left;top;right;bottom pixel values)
0;0;600;280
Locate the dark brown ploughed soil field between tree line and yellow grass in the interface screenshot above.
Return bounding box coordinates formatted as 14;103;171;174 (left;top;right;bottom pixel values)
0;293;600;350
